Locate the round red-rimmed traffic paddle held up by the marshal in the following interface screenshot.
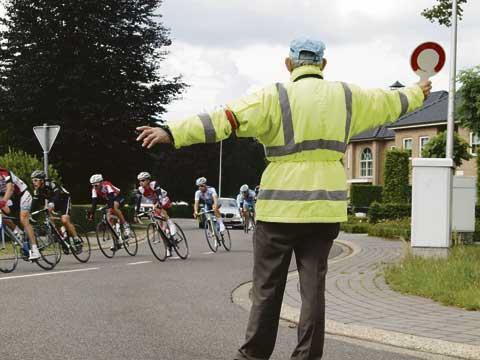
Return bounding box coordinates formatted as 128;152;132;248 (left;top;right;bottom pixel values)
410;41;446;80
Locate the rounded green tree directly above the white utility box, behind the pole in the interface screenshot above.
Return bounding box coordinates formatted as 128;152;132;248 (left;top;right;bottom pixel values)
422;131;472;167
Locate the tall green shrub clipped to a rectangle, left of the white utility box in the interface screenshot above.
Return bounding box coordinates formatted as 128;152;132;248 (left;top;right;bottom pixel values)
382;150;410;203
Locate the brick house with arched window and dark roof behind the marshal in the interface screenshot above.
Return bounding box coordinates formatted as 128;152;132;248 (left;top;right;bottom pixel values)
344;81;480;185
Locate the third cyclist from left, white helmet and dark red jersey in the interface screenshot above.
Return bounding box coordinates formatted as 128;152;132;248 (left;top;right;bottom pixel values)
88;174;130;248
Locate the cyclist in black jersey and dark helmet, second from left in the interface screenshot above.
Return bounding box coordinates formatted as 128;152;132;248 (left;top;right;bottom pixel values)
31;170;82;254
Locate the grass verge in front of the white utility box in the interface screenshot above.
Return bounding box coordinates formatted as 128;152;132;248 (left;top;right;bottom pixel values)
385;245;480;310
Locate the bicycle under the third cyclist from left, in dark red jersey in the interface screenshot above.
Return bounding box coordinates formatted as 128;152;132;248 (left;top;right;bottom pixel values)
95;206;138;258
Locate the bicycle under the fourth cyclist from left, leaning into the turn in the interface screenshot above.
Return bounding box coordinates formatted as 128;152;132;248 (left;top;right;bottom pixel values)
138;209;190;261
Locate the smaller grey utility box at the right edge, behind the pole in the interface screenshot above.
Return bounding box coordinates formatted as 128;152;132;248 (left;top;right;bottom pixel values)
452;176;477;232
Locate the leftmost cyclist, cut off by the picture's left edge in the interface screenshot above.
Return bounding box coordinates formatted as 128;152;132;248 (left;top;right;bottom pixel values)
0;167;41;260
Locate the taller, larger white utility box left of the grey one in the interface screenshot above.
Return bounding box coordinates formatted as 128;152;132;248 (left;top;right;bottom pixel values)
411;158;453;251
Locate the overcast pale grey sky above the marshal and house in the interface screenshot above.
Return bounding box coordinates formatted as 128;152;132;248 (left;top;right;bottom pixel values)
160;0;480;120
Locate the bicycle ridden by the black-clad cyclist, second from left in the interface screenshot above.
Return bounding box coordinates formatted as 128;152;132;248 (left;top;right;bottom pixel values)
32;209;92;263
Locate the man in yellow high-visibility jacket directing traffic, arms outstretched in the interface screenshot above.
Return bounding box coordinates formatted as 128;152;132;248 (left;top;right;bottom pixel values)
138;38;431;360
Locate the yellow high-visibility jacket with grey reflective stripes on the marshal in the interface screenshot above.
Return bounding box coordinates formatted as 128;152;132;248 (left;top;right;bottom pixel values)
169;66;424;223
